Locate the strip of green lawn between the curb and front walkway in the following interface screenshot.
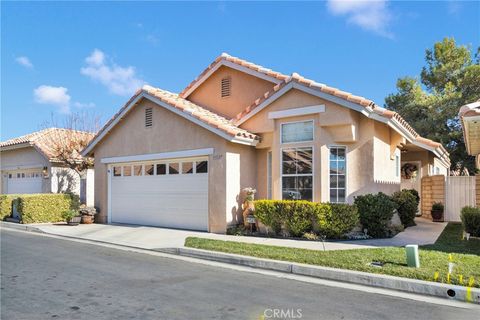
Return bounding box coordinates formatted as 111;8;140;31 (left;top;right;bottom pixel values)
185;223;480;288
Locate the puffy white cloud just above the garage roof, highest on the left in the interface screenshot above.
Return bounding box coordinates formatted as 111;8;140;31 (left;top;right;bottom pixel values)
80;49;145;96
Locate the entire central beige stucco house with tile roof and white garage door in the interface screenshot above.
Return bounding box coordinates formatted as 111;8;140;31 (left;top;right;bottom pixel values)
83;54;450;233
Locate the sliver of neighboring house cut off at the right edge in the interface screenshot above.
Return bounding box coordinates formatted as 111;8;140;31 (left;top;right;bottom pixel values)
458;100;480;169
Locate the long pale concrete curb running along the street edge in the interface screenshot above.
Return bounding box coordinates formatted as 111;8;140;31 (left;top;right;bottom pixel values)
0;221;480;304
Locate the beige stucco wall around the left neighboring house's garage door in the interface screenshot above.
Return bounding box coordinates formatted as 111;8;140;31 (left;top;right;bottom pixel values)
0;147;51;193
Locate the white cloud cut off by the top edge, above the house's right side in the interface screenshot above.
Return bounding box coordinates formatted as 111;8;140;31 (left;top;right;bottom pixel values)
327;0;393;38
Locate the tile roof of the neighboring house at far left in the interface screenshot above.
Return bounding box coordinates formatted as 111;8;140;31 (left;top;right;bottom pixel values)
0;128;94;161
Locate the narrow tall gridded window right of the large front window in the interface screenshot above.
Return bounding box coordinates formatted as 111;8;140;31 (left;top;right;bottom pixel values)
330;147;347;203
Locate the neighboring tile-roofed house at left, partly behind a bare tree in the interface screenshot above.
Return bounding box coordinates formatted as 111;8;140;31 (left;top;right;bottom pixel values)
0;128;94;205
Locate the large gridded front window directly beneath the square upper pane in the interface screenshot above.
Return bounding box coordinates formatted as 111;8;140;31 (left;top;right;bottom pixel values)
282;148;313;201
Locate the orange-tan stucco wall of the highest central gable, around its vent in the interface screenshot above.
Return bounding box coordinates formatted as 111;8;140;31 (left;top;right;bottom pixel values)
188;66;274;118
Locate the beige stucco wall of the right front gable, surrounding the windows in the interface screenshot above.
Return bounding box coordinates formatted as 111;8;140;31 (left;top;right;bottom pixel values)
242;89;400;202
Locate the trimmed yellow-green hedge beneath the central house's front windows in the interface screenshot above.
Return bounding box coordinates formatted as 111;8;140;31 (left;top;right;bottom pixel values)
255;200;359;238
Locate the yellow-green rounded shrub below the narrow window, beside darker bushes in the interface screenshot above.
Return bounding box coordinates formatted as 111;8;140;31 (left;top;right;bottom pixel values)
315;203;359;239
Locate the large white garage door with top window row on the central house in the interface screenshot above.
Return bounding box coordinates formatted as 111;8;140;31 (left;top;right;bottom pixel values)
110;158;208;231
